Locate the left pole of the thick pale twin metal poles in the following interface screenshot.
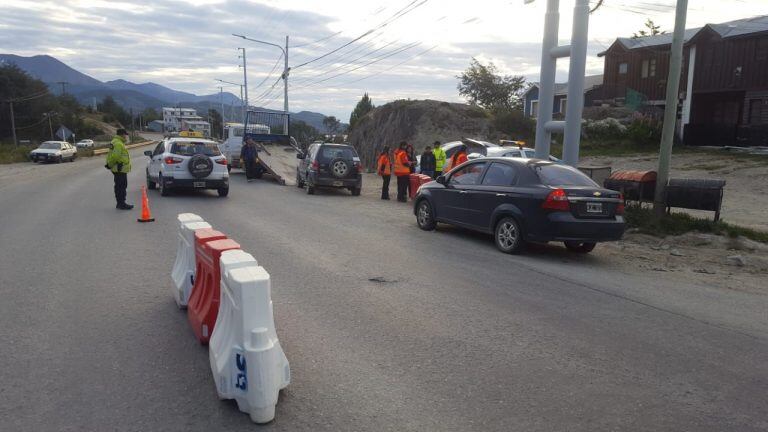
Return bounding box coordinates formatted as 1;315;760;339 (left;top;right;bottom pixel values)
536;0;560;159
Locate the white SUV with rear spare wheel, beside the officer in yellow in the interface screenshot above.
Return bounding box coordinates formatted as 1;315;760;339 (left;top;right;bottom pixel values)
144;137;229;197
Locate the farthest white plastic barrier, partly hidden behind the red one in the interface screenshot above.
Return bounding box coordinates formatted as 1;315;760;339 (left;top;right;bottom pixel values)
171;213;211;308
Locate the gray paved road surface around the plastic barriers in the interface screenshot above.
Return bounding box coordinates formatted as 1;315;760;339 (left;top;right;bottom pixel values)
0;149;768;432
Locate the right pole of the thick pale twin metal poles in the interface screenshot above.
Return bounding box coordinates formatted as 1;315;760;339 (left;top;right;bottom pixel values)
563;0;589;167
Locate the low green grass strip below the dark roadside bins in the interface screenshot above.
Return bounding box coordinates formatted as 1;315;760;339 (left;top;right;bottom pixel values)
625;205;768;243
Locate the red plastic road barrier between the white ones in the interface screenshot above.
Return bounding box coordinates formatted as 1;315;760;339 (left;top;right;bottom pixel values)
187;236;240;344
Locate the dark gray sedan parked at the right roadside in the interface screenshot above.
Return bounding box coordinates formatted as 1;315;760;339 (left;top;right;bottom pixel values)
414;157;624;253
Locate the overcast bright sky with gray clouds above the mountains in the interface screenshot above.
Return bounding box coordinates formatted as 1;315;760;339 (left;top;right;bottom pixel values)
0;0;768;121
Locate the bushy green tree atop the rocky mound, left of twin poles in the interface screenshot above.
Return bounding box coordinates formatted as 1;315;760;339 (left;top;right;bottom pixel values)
456;58;525;111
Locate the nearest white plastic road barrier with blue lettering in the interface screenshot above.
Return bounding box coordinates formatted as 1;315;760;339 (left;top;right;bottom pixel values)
208;250;291;423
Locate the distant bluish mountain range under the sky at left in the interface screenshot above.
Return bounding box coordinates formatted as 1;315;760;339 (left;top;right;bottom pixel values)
0;54;334;131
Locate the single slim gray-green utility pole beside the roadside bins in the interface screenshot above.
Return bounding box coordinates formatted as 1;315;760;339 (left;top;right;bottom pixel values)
653;0;691;219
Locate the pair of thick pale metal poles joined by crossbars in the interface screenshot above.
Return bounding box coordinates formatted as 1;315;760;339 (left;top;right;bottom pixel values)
536;0;589;167
